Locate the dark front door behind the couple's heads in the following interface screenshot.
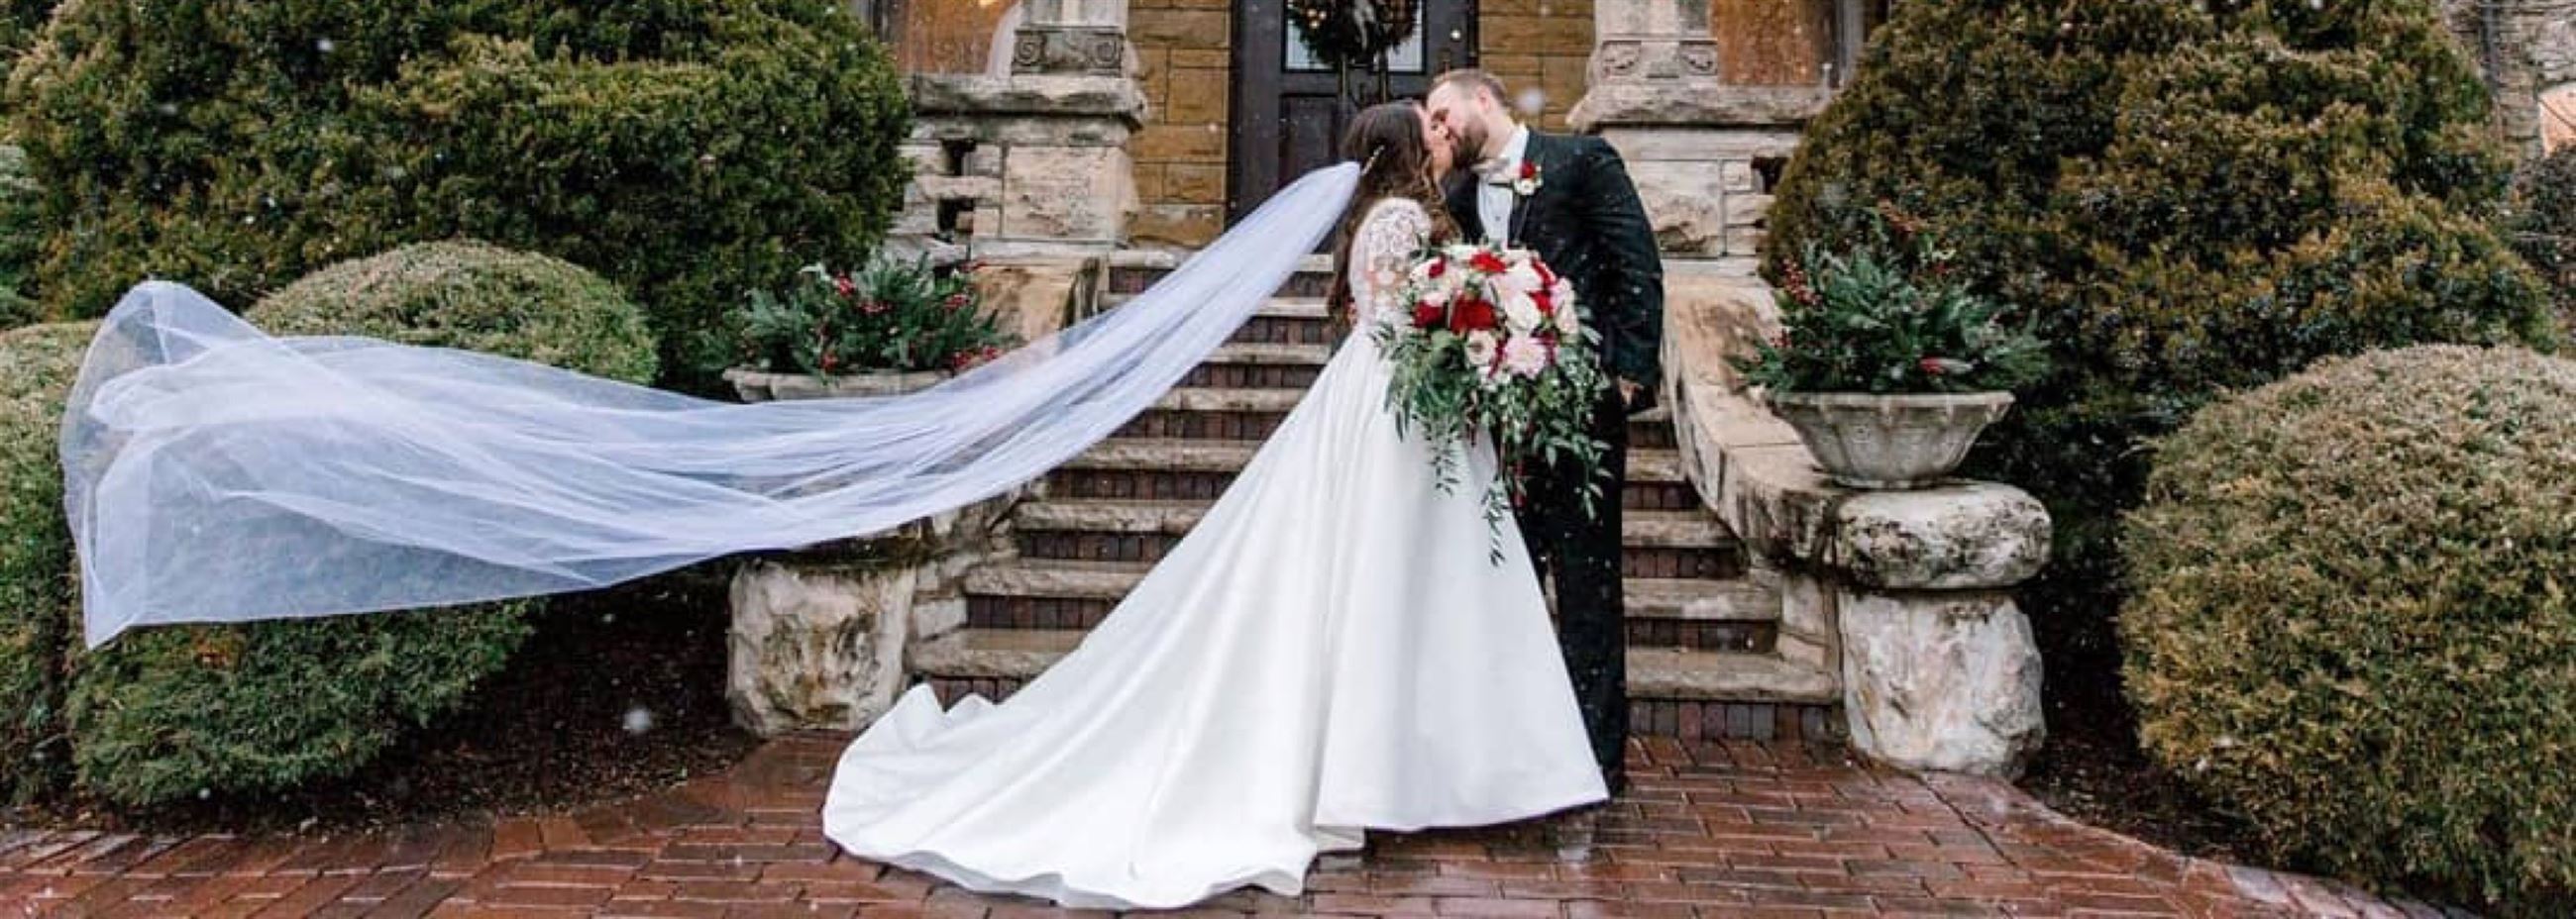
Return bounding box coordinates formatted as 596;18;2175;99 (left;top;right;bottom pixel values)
1227;0;1476;224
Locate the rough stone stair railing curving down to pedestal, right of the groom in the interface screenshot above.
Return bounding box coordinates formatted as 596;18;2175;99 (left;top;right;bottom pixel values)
1664;260;2051;777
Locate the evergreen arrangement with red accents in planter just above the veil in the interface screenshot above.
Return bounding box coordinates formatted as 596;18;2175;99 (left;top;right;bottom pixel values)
726;257;1018;402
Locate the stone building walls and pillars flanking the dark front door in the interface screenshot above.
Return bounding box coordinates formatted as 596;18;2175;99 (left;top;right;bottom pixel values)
858;0;1885;257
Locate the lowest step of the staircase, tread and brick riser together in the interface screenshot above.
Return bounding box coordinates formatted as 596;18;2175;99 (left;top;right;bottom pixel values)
912;628;1842;739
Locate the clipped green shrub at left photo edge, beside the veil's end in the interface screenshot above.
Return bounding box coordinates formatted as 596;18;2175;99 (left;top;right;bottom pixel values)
0;322;98;800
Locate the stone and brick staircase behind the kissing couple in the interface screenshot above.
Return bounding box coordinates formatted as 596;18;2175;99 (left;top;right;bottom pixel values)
910;254;1839;739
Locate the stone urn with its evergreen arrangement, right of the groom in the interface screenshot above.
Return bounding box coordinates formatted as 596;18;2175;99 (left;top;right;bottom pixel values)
1736;206;2048;489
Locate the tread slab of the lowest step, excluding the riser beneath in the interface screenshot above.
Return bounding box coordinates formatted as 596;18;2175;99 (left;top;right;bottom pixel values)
912;628;1842;705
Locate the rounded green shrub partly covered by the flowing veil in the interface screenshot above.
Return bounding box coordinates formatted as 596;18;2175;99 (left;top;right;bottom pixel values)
47;242;654;806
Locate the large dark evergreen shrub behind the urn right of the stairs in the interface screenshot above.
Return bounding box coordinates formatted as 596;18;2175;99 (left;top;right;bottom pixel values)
1765;0;2555;703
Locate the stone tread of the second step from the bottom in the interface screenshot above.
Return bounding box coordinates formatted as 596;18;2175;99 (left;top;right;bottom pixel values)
966;559;1780;623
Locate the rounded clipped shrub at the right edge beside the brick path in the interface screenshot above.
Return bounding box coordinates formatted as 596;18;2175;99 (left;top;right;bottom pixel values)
2120;348;2576;916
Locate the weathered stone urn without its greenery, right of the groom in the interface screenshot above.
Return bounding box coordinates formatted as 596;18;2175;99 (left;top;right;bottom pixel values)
1768;391;2012;489
